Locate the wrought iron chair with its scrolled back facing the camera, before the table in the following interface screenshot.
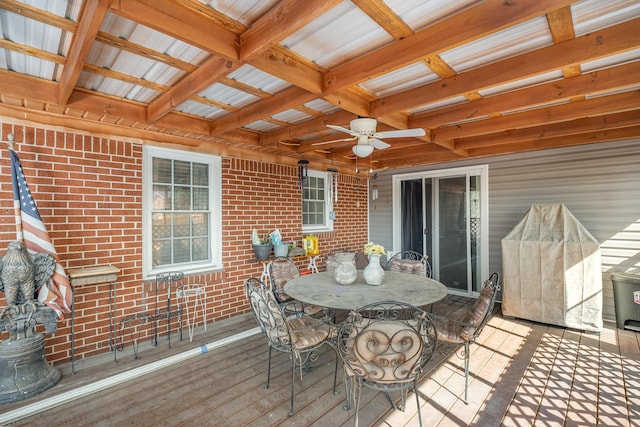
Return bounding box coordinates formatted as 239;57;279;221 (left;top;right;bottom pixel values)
337;301;437;426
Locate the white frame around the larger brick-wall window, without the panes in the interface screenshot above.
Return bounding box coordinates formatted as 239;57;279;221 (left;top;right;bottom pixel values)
142;145;222;277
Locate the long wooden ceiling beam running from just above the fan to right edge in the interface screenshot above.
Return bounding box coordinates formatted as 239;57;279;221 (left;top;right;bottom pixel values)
371;18;640;116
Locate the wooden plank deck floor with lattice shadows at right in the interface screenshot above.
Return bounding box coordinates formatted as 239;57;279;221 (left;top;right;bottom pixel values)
0;297;640;427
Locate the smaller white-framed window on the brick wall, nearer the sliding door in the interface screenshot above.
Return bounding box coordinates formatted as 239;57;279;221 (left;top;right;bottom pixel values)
302;170;333;233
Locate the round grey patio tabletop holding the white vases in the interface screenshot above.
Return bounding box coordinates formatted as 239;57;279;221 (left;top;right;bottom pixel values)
284;270;447;310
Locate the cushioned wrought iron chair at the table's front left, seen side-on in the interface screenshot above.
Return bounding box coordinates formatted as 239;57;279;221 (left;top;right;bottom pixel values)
245;277;338;416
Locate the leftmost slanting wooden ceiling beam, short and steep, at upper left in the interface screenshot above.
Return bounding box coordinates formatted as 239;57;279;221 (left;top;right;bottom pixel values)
58;0;111;105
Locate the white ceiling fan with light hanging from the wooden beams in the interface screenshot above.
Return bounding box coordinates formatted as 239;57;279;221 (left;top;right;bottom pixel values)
314;118;426;157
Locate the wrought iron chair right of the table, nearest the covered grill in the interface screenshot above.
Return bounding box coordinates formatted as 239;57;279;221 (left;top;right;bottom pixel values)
433;273;500;403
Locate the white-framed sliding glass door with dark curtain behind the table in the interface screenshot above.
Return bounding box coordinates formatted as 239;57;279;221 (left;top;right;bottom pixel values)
393;167;488;295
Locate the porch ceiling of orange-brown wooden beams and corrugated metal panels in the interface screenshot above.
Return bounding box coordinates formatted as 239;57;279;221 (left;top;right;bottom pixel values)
0;0;640;172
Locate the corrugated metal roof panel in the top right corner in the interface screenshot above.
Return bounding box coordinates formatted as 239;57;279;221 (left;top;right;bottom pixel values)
571;0;640;37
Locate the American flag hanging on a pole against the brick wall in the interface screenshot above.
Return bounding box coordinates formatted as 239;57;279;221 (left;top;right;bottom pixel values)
9;150;73;319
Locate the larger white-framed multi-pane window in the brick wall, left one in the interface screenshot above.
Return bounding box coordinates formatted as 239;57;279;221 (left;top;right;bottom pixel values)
142;146;222;276
